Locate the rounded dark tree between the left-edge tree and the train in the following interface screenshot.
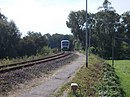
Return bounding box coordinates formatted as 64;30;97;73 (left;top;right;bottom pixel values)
19;31;48;56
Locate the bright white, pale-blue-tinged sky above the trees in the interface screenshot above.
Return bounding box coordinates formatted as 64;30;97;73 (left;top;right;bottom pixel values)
0;0;130;36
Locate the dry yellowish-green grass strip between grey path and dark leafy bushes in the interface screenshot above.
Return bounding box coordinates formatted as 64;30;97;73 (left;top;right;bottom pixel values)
52;55;103;97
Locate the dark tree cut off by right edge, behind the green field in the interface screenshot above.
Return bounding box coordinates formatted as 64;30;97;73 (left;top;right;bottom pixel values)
116;11;130;59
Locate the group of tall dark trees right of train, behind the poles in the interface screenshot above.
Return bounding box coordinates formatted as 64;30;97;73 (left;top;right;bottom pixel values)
66;0;130;59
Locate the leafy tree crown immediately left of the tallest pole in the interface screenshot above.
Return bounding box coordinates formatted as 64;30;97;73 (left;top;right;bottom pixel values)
66;10;89;48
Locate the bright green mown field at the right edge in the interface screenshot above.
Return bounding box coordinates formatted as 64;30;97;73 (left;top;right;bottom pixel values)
107;60;130;97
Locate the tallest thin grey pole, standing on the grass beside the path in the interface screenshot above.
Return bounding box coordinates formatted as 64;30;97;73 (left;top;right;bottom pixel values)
86;0;88;67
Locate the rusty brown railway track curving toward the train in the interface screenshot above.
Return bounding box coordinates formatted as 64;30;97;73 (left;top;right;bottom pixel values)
0;53;72;73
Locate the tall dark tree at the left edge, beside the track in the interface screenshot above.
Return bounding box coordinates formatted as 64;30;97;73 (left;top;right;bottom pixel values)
0;13;21;58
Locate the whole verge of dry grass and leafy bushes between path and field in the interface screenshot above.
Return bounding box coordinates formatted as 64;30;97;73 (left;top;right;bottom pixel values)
52;55;125;97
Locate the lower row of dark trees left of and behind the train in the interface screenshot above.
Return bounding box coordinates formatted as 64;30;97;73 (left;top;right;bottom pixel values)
0;12;73;58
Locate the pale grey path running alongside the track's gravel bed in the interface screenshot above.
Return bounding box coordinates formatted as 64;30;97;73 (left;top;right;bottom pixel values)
15;53;85;97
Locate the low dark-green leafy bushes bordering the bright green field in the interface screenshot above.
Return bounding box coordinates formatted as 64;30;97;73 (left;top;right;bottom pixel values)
98;64;125;97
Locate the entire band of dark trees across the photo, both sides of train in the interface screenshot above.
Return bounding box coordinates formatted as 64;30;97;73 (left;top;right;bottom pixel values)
0;0;130;59
